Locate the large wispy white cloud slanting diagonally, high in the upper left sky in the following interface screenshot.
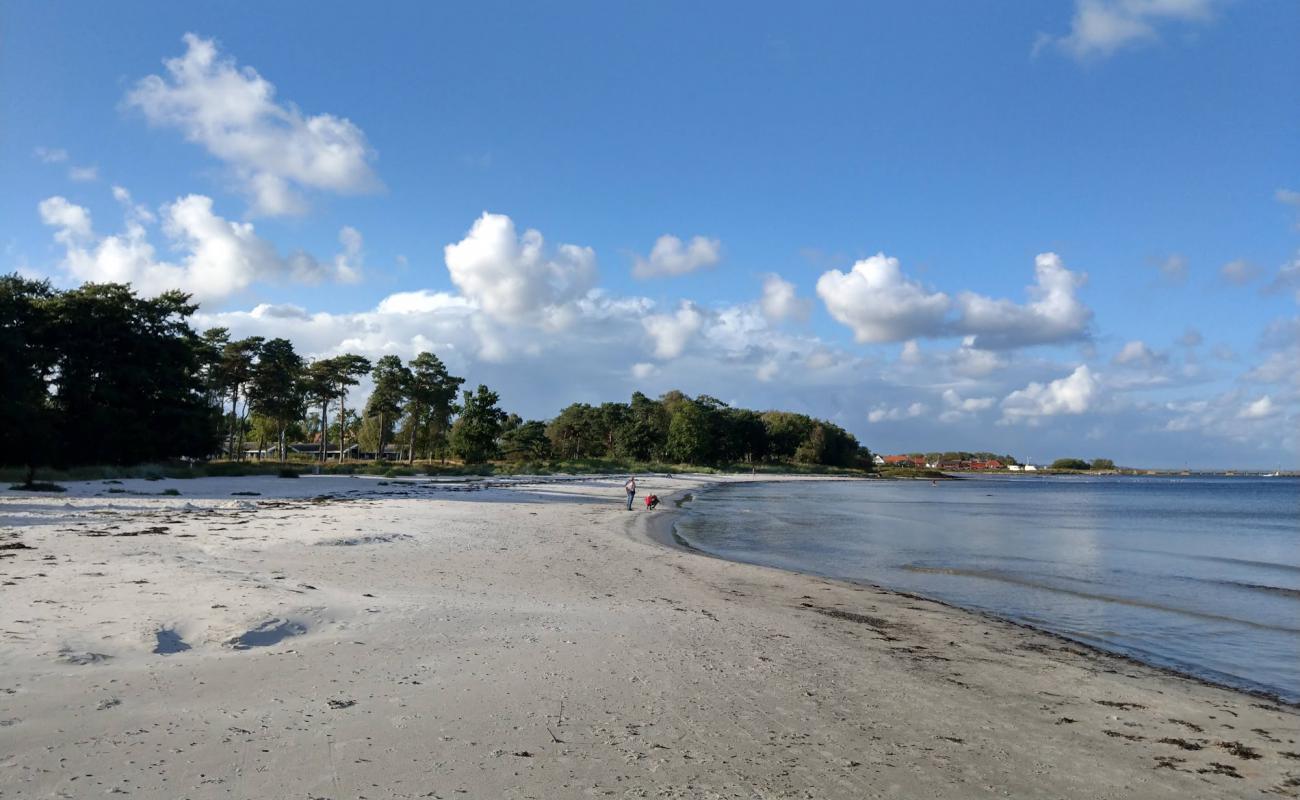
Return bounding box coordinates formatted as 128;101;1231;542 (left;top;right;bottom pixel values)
126;34;380;216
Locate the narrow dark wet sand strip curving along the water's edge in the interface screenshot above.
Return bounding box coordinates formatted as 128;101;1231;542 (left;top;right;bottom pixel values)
644;479;1300;713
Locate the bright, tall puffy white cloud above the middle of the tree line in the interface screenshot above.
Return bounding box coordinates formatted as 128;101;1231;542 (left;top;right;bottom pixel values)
443;212;597;327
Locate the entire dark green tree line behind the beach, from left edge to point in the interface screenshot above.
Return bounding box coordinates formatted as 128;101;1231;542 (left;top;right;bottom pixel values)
0;274;871;476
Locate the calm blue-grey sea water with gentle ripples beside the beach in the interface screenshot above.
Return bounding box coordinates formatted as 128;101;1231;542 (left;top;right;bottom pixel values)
677;476;1300;702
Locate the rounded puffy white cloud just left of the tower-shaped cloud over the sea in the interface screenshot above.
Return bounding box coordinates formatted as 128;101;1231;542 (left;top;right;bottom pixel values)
816;252;952;343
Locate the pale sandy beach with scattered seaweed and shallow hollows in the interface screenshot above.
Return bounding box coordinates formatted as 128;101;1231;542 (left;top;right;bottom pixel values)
0;476;1300;800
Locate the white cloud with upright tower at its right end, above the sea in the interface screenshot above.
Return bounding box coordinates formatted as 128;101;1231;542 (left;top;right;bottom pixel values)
956;252;1092;350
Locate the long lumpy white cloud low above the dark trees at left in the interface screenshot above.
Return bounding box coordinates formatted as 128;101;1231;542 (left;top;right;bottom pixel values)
38;187;361;303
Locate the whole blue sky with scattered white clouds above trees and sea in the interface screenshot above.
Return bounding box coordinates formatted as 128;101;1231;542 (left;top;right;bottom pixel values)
0;0;1300;470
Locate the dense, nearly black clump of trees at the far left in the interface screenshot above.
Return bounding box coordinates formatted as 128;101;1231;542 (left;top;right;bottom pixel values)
0;276;217;468
